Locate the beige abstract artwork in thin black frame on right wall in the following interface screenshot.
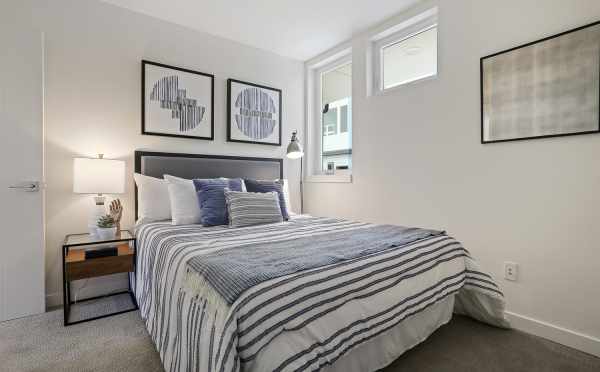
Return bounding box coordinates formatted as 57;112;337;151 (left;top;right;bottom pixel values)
481;22;600;143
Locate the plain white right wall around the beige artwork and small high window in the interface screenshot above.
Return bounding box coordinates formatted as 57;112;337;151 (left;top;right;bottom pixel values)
305;0;600;355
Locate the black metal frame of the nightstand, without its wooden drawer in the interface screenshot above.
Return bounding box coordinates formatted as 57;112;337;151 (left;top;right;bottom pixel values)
62;230;139;327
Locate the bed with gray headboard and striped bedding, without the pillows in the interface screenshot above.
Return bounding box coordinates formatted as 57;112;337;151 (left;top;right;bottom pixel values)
133;151;509;372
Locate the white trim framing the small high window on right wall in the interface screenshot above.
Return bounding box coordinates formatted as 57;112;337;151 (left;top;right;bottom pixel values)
371;9;439;95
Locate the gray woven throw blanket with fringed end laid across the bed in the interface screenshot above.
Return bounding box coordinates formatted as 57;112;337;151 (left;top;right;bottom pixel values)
188;224;443;305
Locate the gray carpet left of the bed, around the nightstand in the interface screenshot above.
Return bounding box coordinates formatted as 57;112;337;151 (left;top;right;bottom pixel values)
0;310;162;372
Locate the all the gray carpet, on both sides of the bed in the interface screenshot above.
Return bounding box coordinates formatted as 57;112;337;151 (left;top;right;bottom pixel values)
0;310;600;372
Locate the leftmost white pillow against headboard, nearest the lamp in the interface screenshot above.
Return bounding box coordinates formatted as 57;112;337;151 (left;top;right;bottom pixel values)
133;173;171;223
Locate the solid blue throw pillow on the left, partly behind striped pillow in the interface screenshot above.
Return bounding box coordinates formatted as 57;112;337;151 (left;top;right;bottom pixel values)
194;178;243;226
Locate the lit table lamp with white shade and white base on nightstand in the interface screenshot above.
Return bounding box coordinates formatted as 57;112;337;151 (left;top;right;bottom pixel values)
73;154;125;236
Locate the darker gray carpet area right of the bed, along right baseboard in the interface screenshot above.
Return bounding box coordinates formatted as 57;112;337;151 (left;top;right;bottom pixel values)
385;316;600;372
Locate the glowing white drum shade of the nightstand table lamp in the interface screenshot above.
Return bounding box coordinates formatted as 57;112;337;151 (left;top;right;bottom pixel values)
73;158;125;194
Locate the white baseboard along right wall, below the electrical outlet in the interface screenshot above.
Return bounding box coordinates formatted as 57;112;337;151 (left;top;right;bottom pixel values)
506;311;600;357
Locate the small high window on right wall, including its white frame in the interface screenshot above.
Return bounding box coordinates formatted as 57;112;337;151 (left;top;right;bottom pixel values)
372;8;438;91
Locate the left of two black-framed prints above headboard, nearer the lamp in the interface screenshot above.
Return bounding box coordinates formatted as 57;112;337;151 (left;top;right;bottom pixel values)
142;61;214;140
